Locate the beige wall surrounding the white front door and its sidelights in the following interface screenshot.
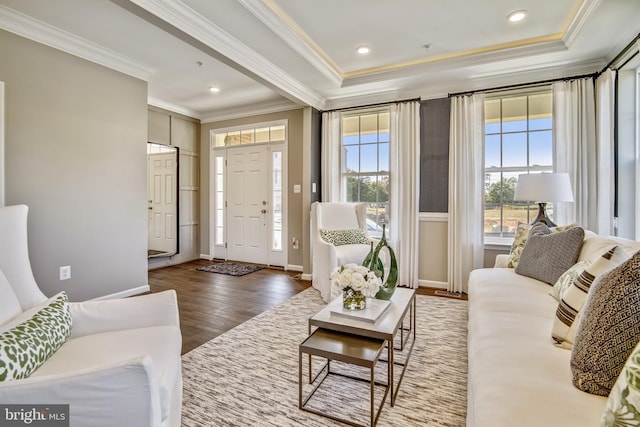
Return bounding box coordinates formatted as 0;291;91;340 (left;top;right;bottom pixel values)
200;109;310;269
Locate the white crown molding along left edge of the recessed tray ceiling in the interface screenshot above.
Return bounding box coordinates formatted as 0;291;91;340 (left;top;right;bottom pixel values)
239;0;342;87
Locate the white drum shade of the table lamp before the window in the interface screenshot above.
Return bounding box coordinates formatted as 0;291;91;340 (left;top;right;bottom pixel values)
513;173;573;203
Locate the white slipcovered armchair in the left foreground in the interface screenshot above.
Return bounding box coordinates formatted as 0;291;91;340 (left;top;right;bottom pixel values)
0;205;182;427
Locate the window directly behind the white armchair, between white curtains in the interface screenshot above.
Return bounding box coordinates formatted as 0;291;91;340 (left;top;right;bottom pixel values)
341;108;389;236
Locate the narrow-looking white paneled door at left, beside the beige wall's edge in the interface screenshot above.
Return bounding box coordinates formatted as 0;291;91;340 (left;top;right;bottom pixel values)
147;153;177;255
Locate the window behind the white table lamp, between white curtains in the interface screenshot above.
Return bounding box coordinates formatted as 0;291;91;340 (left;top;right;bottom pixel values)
484;88;553;243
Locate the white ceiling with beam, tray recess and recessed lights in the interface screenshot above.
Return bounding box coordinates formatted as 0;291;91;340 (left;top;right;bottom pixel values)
0;0;640;121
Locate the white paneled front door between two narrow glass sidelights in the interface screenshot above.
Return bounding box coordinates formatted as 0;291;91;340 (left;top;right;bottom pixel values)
226;145;269;264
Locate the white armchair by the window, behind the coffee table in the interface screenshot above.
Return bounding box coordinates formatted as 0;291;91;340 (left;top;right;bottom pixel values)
310;202;371;302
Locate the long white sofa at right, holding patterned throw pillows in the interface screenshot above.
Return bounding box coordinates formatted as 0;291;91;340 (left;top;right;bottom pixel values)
467;231;640;427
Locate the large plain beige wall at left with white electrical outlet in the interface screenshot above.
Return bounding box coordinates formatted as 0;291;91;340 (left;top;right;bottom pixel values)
0;30;147;301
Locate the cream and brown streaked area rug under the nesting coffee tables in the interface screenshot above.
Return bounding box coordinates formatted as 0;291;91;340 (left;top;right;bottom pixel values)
182;288;467;427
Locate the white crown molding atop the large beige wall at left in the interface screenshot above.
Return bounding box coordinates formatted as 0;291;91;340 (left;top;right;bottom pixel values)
0;5;155;81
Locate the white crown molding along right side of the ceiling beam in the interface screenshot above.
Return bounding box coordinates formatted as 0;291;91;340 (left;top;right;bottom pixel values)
129;0;325;109
